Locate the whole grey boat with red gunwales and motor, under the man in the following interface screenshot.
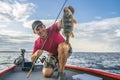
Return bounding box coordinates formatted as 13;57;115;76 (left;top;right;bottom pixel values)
0;50;120;80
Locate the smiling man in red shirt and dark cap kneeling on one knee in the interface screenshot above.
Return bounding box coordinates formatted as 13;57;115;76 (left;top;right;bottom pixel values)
31;5;71;80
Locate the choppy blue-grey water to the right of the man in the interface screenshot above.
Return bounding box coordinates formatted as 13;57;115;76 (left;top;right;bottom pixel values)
67;52;120;74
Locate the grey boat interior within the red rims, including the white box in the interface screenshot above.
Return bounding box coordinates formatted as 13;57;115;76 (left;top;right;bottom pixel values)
0;65;117;80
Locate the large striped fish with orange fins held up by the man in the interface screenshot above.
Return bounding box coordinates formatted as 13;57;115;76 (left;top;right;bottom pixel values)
62;6;76;43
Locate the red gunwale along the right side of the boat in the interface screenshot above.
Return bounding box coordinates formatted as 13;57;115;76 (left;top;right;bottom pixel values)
65;65;120;80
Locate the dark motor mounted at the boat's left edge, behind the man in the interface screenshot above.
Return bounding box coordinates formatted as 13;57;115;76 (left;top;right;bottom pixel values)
14;49;25;65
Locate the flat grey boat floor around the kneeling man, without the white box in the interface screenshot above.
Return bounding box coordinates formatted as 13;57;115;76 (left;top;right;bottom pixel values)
1;64;78;80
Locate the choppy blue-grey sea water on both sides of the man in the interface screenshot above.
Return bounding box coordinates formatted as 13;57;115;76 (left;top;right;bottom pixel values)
0;51;120;75
